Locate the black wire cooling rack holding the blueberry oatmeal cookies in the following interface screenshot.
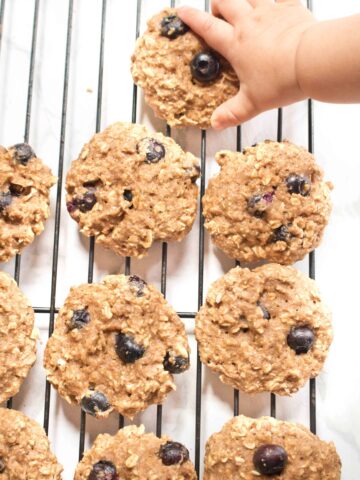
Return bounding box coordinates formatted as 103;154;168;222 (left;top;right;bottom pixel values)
0;0;316;478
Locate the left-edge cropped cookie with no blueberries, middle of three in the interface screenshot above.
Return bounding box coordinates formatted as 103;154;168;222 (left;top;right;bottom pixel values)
0;272;37;403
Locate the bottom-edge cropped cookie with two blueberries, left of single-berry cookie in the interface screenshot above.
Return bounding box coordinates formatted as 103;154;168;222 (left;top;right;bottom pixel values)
74;425;197;480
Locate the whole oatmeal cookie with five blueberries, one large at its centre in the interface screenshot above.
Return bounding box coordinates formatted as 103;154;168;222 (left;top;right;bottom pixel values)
44;275;189;418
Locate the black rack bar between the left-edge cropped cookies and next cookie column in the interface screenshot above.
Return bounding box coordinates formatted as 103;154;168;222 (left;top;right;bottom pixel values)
44;0;74;434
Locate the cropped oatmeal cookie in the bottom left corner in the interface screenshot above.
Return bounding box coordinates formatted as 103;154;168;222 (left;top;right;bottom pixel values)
0;408;63;480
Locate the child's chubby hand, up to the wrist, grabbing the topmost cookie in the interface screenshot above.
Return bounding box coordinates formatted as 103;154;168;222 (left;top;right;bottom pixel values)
178;0;316;129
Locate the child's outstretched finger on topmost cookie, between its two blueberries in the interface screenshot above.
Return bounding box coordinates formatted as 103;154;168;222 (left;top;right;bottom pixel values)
177;7;234;59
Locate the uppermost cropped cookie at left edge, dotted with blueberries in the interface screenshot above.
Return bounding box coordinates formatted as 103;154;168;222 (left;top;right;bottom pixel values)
0;143;56;262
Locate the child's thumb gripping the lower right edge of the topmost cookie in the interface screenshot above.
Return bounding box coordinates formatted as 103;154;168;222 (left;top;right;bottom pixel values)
211;89;258;130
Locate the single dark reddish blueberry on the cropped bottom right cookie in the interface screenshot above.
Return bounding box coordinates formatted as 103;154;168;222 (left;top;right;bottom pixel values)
253;445;288;475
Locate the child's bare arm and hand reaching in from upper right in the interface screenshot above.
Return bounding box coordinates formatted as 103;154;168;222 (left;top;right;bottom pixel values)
178;0;360;128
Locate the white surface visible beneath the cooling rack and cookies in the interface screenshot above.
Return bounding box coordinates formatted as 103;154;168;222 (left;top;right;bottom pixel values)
0;0;360;480
